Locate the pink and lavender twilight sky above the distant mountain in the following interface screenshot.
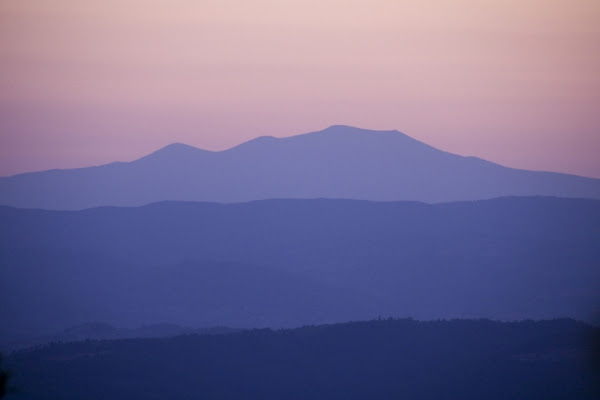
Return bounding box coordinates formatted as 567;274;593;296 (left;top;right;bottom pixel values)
0;0;600;178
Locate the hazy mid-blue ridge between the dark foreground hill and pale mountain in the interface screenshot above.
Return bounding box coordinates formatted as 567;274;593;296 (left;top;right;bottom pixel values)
0;198;600;335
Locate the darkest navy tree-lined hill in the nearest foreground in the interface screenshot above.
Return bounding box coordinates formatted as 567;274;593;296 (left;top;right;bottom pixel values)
6;320;600;400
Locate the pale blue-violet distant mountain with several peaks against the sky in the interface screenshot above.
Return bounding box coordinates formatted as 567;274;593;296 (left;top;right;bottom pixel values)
0;125;600;209
